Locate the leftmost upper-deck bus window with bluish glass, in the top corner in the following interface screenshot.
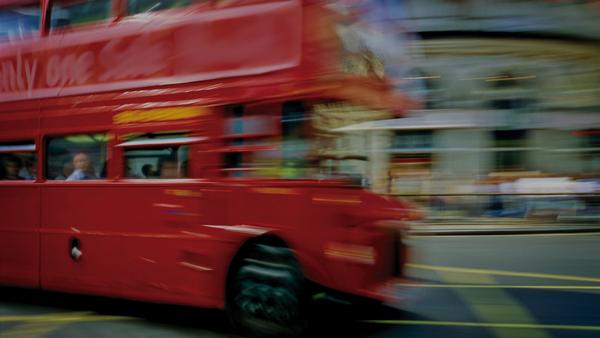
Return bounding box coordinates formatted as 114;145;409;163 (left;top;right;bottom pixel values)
0;4;41;43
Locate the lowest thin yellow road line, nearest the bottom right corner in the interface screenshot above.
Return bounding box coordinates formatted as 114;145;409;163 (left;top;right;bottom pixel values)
364;319;600;331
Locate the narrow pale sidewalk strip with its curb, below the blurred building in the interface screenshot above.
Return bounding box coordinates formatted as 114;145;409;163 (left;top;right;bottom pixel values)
409;220;600;236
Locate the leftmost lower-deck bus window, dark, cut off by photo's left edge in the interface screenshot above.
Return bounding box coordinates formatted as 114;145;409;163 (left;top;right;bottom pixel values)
0;142;37;181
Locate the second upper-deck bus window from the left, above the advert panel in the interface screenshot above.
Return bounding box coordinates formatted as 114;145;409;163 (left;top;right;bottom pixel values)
50;0;111;30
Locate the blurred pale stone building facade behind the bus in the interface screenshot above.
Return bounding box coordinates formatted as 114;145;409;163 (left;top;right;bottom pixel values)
332;0;600;219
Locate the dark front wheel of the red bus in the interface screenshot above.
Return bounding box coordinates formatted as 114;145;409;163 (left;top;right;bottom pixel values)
227;244;307;337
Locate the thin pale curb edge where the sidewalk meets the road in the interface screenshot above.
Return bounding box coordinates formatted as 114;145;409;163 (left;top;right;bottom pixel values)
408;227;600;236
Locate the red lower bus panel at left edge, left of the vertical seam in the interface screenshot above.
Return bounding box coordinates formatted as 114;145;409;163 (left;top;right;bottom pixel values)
0;182;40;288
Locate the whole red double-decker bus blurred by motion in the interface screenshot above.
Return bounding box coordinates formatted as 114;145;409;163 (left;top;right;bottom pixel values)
0;0;415;334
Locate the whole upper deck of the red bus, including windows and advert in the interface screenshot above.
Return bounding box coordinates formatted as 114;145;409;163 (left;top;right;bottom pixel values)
0;0;403;111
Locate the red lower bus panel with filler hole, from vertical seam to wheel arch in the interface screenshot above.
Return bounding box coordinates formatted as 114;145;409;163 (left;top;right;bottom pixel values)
42;182;221;306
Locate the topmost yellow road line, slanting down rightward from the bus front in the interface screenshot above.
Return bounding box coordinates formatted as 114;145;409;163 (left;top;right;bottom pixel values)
406;263;600;283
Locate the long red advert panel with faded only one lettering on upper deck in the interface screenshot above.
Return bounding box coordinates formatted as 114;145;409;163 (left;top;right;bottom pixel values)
0;1;302;101
